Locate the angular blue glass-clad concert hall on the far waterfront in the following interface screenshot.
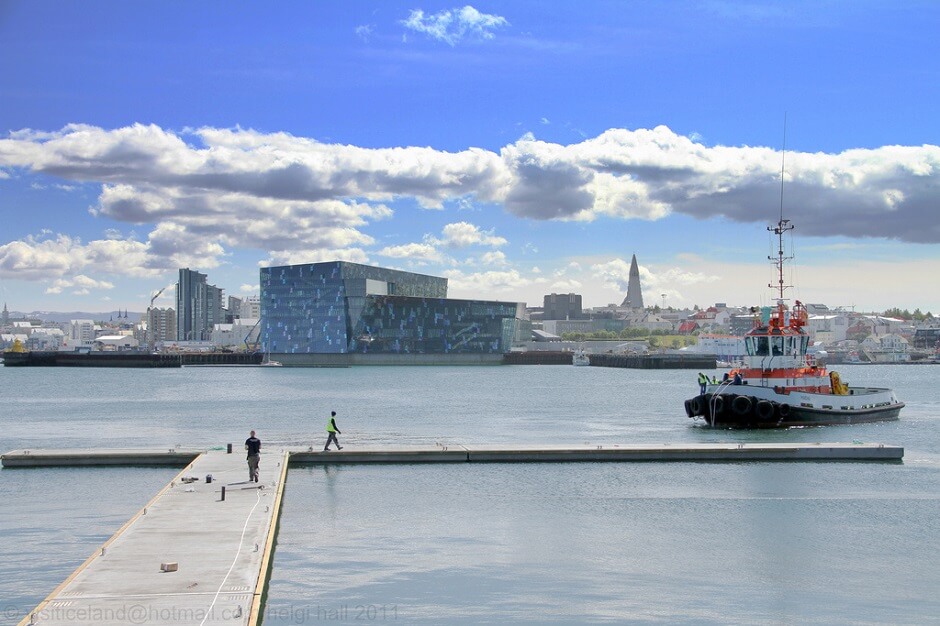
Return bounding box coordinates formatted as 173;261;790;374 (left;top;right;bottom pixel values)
261;261;531;366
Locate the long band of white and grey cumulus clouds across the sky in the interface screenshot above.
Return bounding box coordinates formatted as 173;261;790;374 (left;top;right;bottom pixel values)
0;120;940;283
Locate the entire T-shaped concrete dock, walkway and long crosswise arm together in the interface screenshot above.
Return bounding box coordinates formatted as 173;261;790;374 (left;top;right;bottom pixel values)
0;443;904;626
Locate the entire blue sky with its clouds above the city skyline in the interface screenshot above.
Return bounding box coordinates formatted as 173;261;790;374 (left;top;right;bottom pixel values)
0;1;940;314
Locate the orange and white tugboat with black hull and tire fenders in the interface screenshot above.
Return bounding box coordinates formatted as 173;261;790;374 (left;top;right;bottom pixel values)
685;212;904;428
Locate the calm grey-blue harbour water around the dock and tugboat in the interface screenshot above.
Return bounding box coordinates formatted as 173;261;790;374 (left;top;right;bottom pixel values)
0;366;940;624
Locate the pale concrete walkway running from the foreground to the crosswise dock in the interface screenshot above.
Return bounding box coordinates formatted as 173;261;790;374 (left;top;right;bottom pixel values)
14;451;287;626
